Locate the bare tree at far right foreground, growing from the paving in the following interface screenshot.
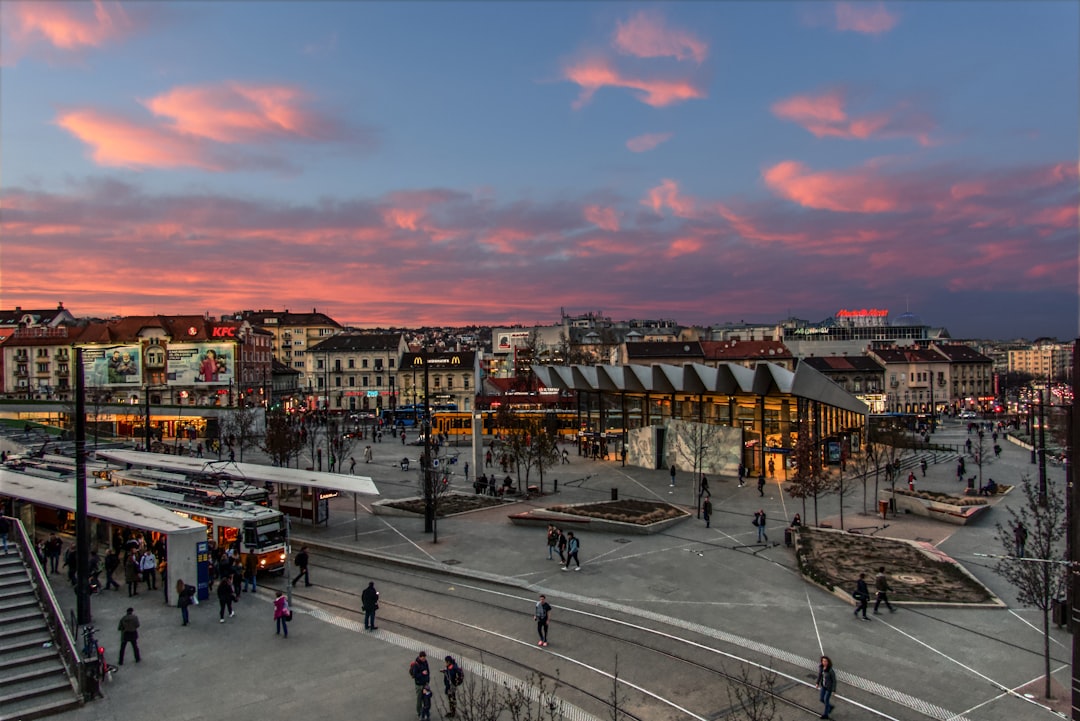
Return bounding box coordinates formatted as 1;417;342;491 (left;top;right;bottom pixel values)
994;476;1068;698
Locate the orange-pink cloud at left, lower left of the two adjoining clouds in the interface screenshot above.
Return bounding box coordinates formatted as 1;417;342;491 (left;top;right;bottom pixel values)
56;110;225;171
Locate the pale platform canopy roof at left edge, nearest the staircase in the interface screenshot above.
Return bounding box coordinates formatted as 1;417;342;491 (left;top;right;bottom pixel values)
0;468;206;534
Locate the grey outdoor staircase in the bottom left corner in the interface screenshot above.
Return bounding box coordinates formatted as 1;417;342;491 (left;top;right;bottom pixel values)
0;546;82;721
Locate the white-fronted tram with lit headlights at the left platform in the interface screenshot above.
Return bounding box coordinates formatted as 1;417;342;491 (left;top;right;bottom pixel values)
117;485;285;573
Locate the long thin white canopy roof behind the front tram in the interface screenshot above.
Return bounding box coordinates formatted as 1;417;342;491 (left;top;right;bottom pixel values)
97;450;379;495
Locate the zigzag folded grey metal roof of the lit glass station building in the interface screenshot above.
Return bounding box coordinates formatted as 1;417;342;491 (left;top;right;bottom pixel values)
532;362;869;416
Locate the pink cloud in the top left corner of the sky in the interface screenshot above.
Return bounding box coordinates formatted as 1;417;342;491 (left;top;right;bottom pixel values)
3;0;133;51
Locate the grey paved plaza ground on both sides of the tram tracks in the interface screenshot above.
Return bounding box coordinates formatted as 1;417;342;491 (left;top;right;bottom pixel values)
8;422;1071;721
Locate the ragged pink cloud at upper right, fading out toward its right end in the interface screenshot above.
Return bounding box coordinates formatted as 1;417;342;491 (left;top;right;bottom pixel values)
772;89;934;146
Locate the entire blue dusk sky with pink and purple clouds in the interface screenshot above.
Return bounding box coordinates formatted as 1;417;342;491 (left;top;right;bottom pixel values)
0;0;1080;340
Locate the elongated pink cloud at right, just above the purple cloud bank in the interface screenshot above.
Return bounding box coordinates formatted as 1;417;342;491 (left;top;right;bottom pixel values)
762;161;907;213
